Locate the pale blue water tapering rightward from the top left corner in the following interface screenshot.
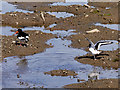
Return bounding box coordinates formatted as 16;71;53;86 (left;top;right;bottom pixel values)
0;1;33;14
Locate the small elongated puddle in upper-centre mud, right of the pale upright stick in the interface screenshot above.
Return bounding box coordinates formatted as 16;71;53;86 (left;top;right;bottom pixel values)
47;12;74;18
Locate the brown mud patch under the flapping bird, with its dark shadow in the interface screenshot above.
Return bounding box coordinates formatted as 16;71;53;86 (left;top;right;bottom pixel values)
75;50;119;69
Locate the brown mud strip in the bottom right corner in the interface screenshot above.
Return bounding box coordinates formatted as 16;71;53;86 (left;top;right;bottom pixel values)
64;79;118;88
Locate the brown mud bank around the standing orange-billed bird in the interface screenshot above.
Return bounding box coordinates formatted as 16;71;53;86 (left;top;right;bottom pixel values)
2;31;55;58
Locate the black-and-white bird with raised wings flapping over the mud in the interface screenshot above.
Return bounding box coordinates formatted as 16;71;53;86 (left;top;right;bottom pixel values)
85;37;113;59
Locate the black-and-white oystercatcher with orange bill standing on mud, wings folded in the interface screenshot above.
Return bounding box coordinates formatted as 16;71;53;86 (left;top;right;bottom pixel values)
14;29;29;45
